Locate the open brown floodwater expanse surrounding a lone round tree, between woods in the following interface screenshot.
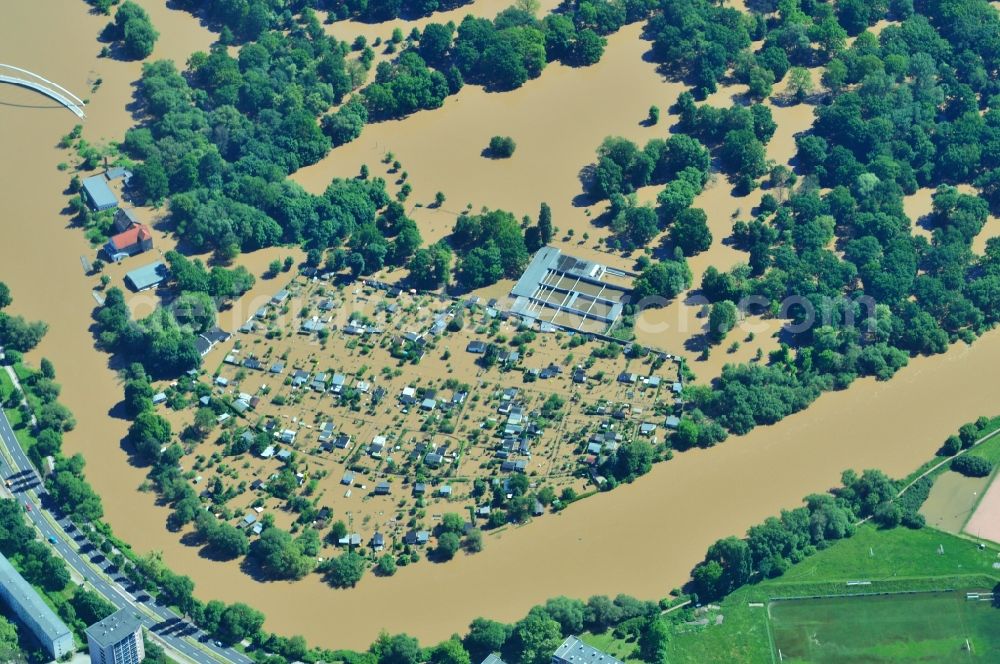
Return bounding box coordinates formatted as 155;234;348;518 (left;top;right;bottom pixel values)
293;24;683;248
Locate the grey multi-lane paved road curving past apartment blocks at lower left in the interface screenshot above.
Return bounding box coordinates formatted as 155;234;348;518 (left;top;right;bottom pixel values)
0;402;253;664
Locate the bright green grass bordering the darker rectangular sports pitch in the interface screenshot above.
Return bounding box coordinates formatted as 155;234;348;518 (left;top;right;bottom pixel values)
668;526;1000;664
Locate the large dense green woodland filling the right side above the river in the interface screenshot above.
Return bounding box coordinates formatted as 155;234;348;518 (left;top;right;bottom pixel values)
616;0;1000;444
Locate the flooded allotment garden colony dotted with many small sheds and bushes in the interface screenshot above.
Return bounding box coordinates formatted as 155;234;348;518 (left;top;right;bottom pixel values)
154;274;681;565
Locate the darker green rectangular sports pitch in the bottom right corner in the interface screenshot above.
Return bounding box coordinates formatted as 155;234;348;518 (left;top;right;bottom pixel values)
769;592;1000;664
